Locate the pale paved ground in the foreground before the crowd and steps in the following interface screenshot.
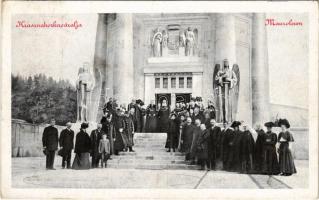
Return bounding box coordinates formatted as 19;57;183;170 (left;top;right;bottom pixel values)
12;157;309;189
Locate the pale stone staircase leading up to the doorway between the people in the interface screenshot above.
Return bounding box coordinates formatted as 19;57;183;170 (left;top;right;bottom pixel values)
108;133;199;169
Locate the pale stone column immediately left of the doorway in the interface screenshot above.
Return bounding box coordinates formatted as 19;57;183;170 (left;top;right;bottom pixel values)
113;13;134;104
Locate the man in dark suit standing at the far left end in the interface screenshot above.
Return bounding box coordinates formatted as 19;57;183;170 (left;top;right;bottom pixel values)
42;119;58;170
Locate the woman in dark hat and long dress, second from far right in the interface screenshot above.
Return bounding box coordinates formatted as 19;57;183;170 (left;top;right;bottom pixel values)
262;122;280;175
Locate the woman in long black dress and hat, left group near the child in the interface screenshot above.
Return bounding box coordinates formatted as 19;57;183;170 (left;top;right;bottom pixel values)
72;123;91;169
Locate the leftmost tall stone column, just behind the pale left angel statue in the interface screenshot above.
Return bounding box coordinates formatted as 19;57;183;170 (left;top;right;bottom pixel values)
88;14;107;122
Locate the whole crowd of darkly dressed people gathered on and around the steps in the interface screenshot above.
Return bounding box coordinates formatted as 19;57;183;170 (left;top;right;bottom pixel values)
43;97;296;176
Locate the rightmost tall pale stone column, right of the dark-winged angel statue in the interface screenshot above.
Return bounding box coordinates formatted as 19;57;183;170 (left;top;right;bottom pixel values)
251;13;270;125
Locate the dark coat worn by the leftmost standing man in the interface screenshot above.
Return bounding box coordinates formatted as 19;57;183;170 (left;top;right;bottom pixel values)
42;126;59;151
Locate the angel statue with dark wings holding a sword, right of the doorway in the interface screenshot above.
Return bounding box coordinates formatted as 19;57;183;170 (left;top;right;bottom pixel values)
213;59;240;122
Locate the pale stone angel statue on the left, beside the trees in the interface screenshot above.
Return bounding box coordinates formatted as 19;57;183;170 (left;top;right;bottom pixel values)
76;62;94;122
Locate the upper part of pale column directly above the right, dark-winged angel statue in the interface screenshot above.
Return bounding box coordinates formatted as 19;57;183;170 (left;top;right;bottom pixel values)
215;13;236;67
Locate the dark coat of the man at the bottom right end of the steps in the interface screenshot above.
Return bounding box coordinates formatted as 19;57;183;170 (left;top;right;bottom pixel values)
196;129;210;160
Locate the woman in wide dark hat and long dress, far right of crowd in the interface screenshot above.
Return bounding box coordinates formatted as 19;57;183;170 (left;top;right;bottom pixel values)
278;119;297;176
